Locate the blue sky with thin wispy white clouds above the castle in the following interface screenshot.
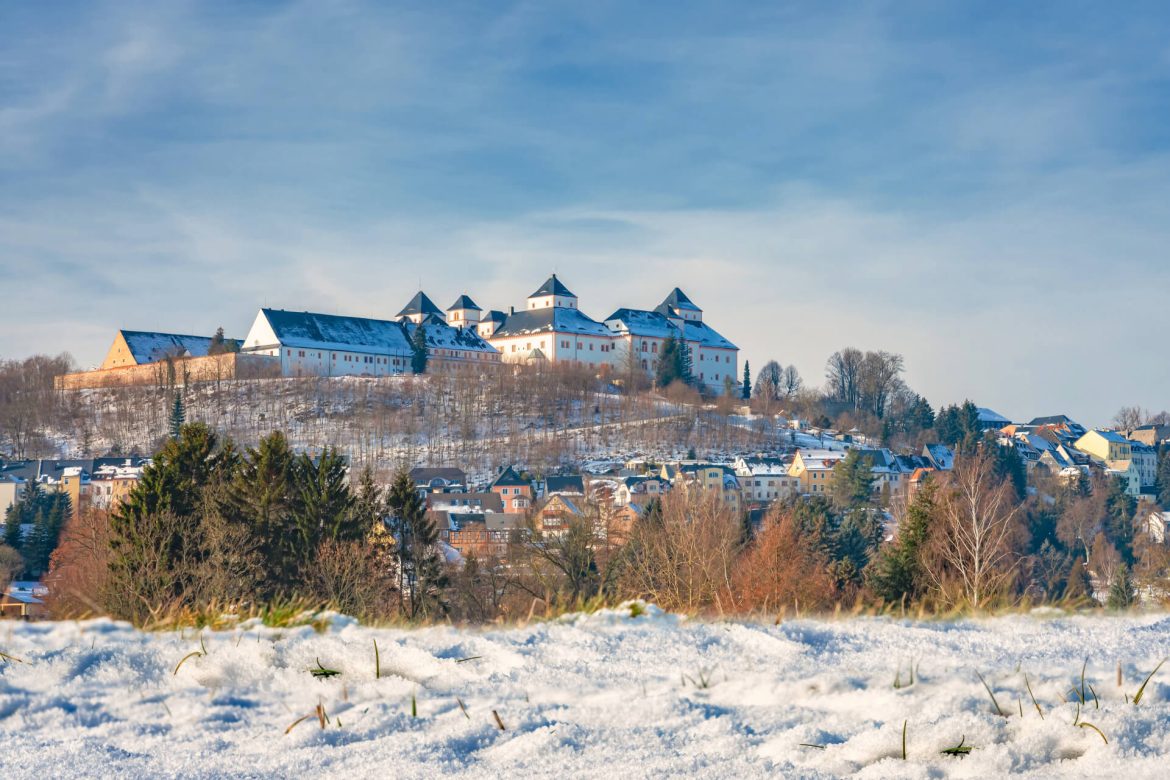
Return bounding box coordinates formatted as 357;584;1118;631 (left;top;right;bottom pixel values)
0;0;1170;424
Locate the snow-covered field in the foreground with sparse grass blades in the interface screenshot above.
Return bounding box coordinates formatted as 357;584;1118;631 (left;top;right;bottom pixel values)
0;608;1170;780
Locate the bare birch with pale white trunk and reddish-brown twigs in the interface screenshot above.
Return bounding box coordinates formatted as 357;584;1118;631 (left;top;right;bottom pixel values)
925;451;1021;609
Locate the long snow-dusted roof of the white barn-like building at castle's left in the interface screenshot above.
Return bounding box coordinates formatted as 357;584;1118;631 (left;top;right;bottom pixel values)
260;309;411;354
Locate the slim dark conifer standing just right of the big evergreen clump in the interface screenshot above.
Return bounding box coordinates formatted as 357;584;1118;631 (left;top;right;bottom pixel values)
386;469;448;620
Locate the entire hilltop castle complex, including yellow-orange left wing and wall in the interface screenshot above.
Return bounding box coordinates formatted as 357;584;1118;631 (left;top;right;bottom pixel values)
59;274;738;392
